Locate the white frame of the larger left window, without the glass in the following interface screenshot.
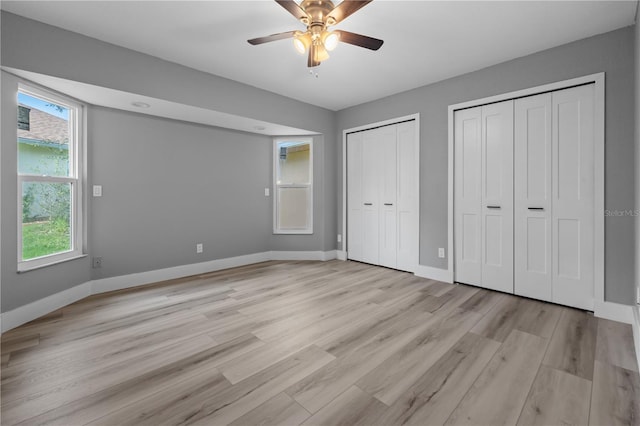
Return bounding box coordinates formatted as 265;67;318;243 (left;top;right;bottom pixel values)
15;82;86;272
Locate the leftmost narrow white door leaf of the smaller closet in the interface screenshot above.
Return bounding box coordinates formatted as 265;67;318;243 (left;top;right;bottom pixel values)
347;133;363;261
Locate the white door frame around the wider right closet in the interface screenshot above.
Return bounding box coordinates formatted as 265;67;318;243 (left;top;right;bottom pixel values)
447;72;605;310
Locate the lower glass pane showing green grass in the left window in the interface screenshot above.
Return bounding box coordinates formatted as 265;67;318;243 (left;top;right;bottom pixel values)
22;182;73;260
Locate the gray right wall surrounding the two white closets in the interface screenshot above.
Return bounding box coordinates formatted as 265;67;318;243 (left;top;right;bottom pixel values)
337;27;635;304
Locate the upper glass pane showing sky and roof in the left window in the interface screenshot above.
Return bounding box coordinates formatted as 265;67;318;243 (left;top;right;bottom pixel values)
17;92;71;176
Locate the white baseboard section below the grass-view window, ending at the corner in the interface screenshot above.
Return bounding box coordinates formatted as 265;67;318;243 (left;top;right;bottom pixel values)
2;282;91;333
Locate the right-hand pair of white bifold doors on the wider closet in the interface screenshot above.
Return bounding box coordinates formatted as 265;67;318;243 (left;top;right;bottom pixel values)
514;85;594;310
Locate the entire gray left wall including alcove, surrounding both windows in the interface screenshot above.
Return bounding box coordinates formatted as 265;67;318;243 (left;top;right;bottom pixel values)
0;12;336;312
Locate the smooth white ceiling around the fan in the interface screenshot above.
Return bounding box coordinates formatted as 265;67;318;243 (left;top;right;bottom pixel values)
1;0;638;111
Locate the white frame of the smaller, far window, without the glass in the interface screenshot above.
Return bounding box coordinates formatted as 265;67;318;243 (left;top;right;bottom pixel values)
273;136;314;235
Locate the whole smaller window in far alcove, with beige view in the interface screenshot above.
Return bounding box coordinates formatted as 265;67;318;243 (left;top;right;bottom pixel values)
273;138;313;234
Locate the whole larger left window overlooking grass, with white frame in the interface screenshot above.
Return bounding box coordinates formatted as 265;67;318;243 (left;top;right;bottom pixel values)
17;85;83;271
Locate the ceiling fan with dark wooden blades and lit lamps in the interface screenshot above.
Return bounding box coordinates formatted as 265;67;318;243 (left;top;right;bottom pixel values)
247;0;384;68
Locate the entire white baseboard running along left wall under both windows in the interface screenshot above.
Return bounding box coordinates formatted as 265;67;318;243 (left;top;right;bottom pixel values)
0;250;336;333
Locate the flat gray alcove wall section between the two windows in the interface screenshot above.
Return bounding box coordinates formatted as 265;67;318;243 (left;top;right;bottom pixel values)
88;107;271;279
